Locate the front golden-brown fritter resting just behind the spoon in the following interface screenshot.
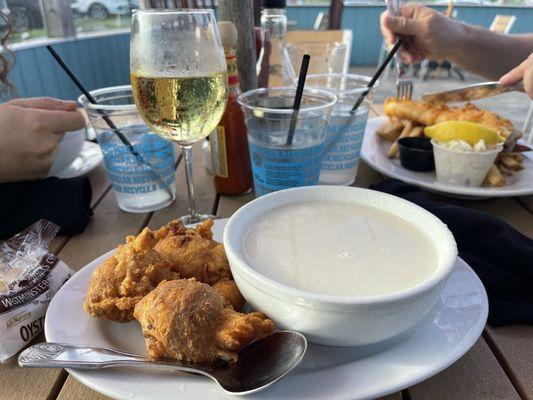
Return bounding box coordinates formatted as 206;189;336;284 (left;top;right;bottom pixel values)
134;279;275;363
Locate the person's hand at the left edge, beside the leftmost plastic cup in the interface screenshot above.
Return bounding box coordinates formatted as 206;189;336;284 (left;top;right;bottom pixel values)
0;97;85;182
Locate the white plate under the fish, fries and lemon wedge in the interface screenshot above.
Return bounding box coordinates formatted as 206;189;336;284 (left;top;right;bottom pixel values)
361;117;533;198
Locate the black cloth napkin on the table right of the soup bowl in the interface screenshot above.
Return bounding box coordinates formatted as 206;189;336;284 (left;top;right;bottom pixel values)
370;179;533;327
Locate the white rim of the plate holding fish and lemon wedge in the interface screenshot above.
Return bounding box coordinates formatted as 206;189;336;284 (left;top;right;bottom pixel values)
361;116;533;199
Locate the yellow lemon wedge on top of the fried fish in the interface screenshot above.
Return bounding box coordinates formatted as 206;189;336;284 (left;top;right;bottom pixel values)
424;121;504;146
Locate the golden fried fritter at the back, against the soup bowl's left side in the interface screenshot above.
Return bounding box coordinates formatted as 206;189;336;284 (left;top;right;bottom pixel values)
155;220;231;285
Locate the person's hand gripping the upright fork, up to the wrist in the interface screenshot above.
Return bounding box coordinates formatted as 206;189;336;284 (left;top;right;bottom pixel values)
380;4;462;63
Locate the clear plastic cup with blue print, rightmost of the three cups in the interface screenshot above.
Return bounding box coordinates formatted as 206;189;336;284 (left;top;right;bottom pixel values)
306;74;378;186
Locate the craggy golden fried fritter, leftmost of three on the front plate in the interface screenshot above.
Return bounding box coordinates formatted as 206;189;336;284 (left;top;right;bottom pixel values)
84;228;180;322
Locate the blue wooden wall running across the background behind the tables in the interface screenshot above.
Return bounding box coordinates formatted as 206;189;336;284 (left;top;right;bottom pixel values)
7;6;533;99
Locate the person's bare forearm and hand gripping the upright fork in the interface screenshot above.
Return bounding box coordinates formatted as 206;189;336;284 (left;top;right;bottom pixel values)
381;4;533;80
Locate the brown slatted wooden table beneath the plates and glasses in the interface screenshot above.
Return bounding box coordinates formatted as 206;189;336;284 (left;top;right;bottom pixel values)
0;136;533;400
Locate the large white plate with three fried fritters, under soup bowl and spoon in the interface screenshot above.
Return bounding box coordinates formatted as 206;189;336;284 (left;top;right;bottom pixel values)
45;220;488;400
